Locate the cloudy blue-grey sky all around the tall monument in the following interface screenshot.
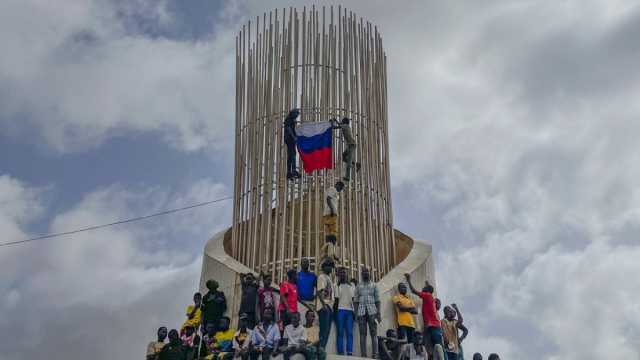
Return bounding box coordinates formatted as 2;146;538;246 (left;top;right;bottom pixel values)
0;0;640;360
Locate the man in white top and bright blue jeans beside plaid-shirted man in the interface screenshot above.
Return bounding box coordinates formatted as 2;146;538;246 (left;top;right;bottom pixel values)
334;268;355;356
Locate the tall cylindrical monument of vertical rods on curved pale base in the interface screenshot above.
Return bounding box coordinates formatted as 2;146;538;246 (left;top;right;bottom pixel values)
201;6;435;354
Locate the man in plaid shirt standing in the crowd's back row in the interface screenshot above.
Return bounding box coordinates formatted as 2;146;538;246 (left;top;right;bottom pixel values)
354;267;382;358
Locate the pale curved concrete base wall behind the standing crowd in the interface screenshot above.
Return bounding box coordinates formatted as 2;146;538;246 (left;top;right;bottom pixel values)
200;231;435;356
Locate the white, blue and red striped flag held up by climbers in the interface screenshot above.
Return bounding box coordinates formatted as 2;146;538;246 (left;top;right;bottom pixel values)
296;121;333;174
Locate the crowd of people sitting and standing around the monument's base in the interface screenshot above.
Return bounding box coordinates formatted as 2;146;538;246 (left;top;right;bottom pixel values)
146;259;500;360
